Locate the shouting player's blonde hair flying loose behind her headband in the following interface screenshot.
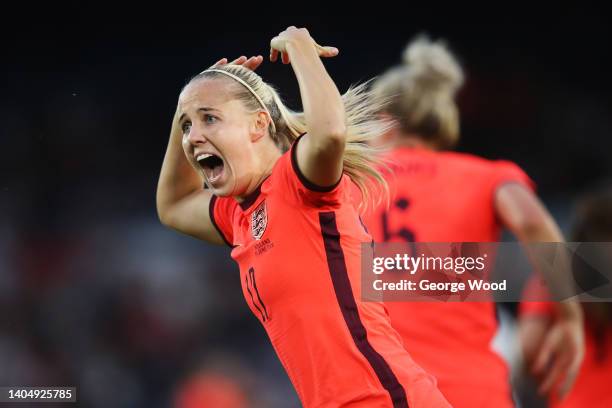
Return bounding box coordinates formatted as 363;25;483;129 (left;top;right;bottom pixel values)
190;64;392;210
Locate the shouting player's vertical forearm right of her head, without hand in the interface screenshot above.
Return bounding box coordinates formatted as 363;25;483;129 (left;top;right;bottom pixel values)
287;41;346;146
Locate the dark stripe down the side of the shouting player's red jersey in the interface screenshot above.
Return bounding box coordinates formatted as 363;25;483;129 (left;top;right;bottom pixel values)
319;211;408;408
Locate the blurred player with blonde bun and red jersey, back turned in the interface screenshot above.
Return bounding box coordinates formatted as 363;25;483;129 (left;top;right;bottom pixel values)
364;38;582;408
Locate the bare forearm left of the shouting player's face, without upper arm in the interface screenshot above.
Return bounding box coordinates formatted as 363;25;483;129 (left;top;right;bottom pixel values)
156;108;202;220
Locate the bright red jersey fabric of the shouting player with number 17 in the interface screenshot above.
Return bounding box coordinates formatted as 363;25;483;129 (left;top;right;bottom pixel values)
213;144;448;407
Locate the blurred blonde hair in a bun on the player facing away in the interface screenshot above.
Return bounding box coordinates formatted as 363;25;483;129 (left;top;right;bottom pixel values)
373;35;464;149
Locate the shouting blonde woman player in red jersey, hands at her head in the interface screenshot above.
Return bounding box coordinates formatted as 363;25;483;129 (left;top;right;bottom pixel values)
157;27;448;407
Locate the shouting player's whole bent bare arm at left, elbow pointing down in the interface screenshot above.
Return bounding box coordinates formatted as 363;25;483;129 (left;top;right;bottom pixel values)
156;108;224;244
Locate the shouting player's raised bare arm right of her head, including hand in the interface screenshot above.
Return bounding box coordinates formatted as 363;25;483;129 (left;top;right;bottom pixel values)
270;27;346;187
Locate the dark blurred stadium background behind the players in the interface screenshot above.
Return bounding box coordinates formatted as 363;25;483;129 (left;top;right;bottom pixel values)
0;7;612;408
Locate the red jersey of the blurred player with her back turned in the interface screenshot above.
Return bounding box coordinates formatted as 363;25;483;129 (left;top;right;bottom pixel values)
364;148;534;408
